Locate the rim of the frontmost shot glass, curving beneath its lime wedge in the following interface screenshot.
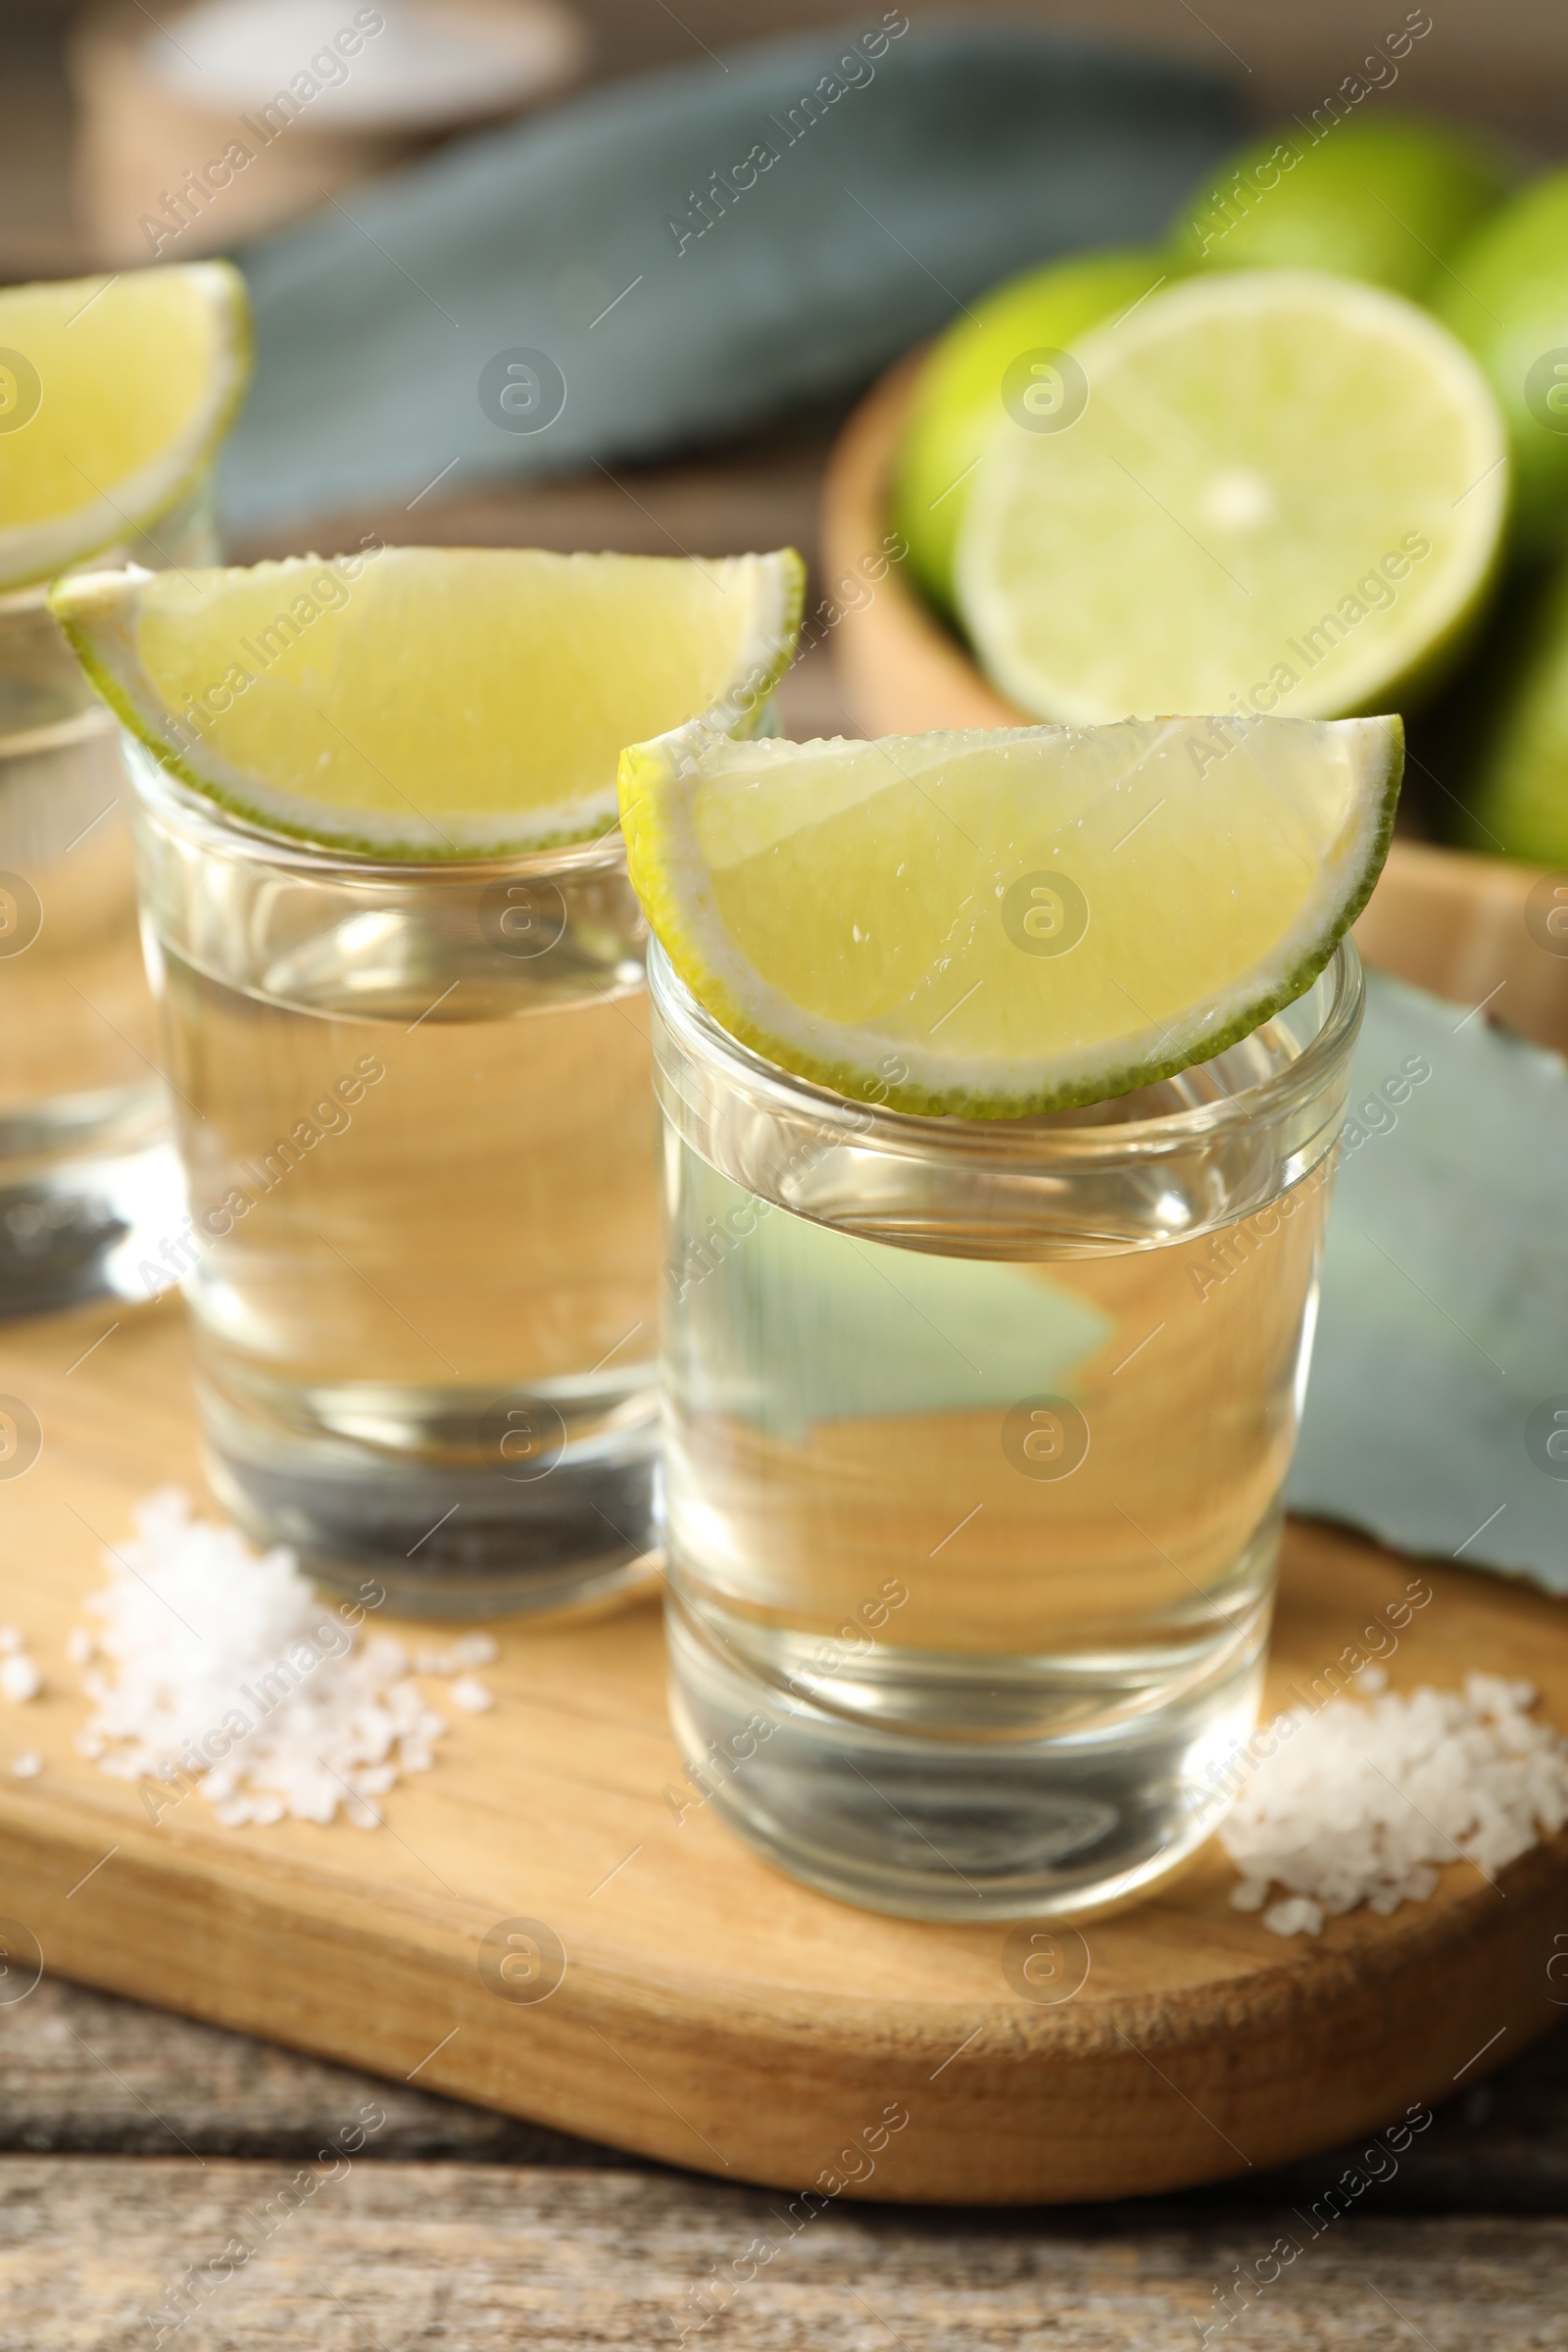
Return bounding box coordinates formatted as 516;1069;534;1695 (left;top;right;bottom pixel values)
647;931;1366;1164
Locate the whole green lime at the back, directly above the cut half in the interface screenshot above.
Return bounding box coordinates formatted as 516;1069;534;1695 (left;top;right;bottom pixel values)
1173;108;1511;301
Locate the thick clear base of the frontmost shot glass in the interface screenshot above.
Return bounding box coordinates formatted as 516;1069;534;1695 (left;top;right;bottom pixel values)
667;1594;1267;1922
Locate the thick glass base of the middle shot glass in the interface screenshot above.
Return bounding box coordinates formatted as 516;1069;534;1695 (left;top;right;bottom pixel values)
197;1381;662;1618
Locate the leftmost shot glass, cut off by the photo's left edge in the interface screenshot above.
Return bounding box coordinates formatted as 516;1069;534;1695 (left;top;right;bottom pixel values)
0;482;217;1315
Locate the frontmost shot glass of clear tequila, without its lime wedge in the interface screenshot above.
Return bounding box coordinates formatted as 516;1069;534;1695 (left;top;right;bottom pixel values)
651;943;1361;1919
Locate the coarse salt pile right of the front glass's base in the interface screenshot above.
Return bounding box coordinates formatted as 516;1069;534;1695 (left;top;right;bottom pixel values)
1220;1670;1568;1936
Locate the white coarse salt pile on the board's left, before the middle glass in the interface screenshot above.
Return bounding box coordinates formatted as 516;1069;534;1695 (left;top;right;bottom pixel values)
77;1489;479;1830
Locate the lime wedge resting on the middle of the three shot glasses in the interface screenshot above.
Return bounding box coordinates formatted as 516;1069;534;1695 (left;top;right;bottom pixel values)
49;548;804;858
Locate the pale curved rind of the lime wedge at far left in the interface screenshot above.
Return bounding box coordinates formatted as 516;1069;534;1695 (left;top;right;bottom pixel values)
0;261;254;593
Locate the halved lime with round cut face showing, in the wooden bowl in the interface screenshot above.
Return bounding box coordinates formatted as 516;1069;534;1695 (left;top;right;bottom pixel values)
956;270;1507;724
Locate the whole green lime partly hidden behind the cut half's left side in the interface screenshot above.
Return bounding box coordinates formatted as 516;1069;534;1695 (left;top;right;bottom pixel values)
894;247;1173;612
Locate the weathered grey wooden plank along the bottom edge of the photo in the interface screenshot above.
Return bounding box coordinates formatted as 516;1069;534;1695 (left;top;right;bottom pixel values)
0;2157;1568;2352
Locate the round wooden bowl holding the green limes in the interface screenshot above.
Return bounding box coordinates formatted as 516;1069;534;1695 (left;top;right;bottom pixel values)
823;353;1568;1054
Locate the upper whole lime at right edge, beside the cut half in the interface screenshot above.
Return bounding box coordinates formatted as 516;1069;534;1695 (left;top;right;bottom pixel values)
1437;170;1568;548
